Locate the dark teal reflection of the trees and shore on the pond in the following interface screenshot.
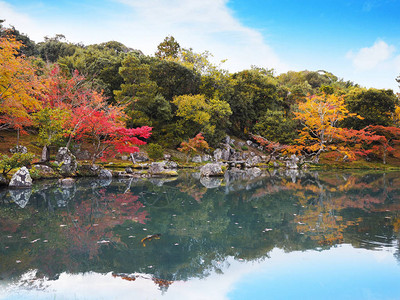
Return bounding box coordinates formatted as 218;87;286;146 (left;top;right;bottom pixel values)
0;171;400;299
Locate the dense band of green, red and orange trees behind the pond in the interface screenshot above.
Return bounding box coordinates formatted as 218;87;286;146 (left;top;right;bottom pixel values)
0;22;400;168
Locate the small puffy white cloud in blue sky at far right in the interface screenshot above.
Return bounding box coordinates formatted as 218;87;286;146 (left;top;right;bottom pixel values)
346;40;395;70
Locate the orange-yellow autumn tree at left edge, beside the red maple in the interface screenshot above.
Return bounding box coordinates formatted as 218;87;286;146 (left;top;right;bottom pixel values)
0;37;44;144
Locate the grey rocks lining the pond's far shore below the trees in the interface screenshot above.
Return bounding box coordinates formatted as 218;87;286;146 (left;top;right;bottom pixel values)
0;136;303;188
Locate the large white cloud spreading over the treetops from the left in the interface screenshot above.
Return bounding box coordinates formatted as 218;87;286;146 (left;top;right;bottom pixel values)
0;0;288;72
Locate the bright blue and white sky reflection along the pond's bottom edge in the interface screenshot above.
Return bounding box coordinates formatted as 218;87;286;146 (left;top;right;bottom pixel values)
0;245;400;300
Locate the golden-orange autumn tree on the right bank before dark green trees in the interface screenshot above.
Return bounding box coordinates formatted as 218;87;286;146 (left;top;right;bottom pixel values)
290;94;361;162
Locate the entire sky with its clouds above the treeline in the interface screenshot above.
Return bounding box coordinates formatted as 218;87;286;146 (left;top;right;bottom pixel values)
0;0;400;92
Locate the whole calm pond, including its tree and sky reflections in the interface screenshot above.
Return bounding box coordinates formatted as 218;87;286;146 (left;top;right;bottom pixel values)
0;171;400;300
